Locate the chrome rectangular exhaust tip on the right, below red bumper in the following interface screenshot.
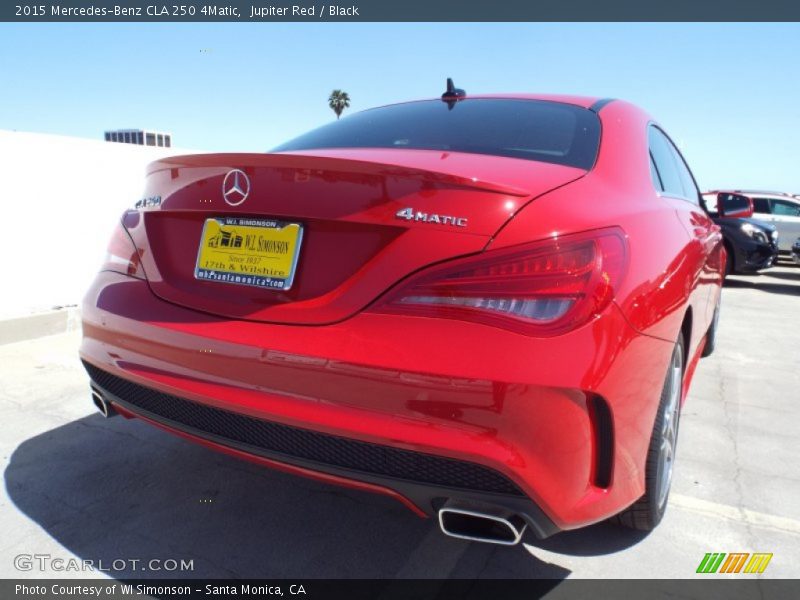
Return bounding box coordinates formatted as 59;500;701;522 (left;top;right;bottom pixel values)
439;504;528;546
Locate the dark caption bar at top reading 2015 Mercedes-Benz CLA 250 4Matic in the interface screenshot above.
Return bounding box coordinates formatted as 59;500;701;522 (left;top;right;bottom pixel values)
0;0;800;22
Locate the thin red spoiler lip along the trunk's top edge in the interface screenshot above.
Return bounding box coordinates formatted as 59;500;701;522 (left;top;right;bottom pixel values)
147;152;552;197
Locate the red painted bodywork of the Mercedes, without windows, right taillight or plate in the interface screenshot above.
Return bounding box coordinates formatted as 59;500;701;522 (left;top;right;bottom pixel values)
81;98;724;528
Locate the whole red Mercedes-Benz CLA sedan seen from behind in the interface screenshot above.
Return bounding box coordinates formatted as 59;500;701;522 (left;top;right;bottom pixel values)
81;89;725;544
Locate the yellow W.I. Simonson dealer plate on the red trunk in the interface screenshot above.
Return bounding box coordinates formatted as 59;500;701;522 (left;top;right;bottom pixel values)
194;217;303;290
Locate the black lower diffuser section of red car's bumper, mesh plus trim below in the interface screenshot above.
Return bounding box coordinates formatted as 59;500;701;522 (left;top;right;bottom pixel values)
84;363;558;538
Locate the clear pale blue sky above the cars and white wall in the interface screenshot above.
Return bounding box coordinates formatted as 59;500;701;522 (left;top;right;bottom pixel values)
0;23;800;192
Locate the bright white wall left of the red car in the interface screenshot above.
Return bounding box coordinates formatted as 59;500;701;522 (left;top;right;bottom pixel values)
0;130;203;318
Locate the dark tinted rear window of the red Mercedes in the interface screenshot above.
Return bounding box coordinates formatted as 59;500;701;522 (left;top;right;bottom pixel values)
273;98;600;170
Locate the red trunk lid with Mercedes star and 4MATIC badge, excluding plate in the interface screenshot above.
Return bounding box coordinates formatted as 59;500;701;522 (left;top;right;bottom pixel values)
125;150;585;324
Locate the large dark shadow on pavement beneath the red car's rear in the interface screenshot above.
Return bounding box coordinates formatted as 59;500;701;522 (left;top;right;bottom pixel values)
4;415;642;580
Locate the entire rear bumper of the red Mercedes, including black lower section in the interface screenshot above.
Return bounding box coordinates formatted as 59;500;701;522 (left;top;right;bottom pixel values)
81;272;672;537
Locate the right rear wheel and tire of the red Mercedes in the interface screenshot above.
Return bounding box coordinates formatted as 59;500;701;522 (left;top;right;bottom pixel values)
616;334;685;531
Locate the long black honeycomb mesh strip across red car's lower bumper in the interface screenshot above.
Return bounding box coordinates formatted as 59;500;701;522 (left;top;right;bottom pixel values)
84;363;524;496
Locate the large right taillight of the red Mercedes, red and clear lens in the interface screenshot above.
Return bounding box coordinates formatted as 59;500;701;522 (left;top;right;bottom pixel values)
371;228;627;336
